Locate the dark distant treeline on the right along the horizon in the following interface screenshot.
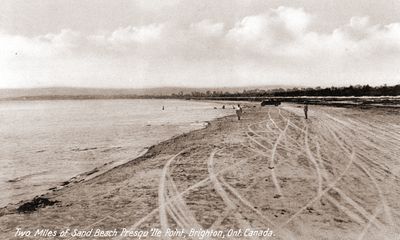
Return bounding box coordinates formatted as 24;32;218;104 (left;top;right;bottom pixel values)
171;85;400;98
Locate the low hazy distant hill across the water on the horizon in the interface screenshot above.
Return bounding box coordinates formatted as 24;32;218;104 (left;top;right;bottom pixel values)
0;85;292;100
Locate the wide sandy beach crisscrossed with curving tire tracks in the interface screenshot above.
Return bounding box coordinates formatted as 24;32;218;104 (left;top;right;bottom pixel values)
0;104;400;239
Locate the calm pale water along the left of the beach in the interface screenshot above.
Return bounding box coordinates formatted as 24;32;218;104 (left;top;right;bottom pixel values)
0;100;233;206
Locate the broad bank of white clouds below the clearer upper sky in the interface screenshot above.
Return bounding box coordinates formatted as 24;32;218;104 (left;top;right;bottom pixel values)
0;7;400;87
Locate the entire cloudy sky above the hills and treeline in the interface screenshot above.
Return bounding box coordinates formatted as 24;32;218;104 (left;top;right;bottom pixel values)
0;0;400;88
